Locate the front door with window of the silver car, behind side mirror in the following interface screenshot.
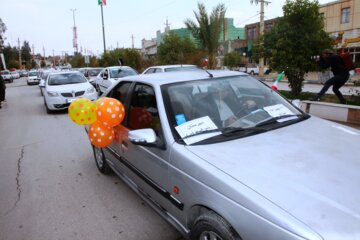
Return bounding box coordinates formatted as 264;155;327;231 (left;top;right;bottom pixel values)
110;83;174;210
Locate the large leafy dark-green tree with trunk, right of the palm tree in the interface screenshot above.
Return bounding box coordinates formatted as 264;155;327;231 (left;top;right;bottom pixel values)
258;0;331;98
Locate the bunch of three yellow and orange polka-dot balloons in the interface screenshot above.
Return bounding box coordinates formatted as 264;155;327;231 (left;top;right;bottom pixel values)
68;97;125;147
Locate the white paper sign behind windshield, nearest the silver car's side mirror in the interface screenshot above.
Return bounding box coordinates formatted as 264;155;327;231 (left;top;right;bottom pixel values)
175;116;221;145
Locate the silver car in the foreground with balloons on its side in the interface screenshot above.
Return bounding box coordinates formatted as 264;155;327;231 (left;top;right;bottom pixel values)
86;70;360;240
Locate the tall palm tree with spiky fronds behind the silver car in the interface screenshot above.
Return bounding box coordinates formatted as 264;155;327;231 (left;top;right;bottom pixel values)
185;3;226;69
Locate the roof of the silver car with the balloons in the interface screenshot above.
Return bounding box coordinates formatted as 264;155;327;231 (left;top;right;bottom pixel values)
121;70;248;86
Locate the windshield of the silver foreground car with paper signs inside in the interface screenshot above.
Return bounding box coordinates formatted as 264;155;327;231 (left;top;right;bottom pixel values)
162;76;306;143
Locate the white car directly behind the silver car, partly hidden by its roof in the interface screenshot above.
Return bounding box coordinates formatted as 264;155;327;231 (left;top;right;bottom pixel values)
96;66;138;93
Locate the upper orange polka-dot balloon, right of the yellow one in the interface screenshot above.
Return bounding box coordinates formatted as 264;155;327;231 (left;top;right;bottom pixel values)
96;97;125;127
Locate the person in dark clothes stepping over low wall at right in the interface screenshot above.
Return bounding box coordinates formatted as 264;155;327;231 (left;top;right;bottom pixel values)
311;49;350;104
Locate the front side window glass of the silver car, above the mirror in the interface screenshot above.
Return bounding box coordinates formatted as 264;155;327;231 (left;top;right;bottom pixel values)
128;84;160;135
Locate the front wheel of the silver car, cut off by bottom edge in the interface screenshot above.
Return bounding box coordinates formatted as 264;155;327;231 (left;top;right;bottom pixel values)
191;211;241;240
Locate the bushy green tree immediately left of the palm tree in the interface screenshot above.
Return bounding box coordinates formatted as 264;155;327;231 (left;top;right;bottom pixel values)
157;32;196;64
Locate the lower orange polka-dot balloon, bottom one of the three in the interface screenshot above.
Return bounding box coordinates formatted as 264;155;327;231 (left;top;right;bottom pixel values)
88;121;114;147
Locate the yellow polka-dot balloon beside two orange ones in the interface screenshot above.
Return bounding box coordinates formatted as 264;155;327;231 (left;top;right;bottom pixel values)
68;98;96;125
